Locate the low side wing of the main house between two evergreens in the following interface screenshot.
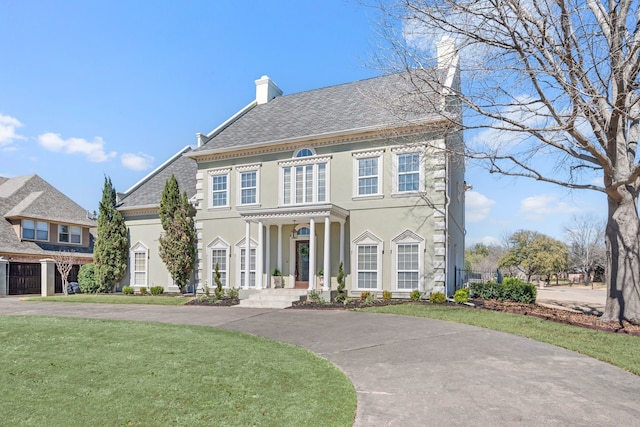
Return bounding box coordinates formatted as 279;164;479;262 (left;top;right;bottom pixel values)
118;146;197;292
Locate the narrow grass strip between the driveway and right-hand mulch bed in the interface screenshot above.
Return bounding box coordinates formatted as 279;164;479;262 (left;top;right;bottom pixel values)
364;304;640;375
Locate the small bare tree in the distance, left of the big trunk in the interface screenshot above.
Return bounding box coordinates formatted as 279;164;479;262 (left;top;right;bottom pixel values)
565;215;605;290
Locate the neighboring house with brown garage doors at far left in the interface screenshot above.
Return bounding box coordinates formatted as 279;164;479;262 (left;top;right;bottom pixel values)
0;175;96;295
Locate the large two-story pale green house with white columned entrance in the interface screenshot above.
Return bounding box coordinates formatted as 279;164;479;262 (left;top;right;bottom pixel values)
119;37;465;297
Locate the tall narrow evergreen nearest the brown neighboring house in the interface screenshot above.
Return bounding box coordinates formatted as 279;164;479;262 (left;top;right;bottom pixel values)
93;177;129;292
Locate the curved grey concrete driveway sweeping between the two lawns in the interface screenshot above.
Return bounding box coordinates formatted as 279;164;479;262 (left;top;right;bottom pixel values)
0;298;640;426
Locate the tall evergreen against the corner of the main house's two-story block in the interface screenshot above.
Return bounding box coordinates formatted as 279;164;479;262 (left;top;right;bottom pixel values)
158;179;196;290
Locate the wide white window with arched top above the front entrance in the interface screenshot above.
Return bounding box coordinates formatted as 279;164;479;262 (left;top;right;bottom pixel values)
280;148;330;205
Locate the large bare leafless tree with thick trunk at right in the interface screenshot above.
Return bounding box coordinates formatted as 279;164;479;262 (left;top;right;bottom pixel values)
372;0;640;322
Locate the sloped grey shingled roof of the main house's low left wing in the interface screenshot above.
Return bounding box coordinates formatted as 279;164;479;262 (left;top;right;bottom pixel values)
118;147;198;210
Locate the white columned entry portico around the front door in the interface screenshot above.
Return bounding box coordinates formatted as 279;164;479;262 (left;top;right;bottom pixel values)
238;204;349;291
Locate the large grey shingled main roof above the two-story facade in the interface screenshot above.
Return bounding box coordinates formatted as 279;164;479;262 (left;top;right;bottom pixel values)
191;74;440;156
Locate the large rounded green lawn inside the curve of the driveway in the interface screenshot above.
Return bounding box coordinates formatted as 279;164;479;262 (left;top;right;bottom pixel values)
0;316;356;426
